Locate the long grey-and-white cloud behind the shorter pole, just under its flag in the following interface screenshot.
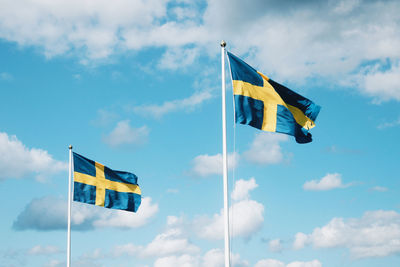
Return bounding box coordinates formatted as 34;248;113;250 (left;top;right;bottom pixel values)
13;197;158;231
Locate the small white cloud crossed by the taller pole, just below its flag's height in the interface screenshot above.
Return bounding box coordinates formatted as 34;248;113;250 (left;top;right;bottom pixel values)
192;153;239;176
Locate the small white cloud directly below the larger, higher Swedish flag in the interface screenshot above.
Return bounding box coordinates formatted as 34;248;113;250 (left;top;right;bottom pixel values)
244;132;288;164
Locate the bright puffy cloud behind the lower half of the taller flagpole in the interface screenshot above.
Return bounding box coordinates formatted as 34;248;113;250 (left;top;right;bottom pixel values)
194;178;264;240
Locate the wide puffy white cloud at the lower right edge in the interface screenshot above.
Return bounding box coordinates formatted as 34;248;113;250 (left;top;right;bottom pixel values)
294;210;400;258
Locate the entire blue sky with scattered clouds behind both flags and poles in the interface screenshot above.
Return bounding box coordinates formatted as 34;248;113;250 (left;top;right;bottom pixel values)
0;0;400;267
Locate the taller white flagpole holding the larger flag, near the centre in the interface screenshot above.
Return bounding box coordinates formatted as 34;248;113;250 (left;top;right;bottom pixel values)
221;40;230;267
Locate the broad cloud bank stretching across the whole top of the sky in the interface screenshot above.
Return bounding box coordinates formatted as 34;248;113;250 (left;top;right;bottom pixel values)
0;0;400;102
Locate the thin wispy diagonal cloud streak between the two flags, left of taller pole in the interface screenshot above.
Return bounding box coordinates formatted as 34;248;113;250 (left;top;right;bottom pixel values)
133;91;212;118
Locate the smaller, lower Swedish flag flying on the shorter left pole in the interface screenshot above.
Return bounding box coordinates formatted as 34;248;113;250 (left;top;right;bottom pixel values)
73;153;141;212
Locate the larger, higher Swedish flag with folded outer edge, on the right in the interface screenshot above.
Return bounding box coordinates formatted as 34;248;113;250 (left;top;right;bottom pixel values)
228;52;321;143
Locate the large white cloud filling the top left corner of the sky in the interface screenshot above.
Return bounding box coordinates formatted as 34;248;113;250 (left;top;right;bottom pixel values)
0;0;167;60
